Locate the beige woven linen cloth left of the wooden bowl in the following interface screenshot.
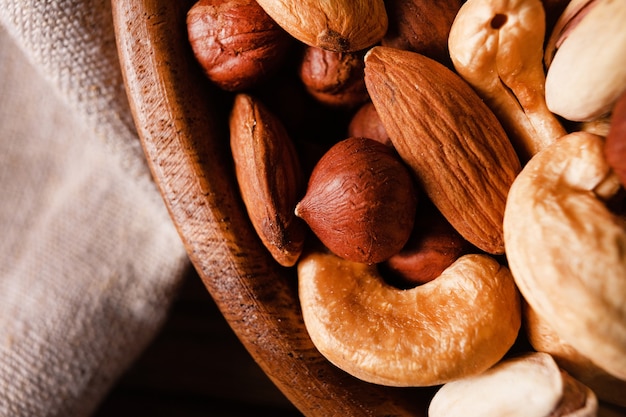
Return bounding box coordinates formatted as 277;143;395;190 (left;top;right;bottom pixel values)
0;0;189;417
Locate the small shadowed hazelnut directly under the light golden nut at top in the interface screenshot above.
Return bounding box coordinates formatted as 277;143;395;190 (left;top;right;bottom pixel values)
299;46;369;108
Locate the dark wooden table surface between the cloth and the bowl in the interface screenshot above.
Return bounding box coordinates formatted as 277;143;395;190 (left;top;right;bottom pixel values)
95;270;302;417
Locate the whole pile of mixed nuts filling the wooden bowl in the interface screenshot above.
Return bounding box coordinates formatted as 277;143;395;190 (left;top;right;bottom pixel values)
187;0;626;416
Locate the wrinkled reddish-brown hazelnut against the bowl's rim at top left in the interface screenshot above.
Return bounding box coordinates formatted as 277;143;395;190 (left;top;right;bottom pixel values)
187;0;293;91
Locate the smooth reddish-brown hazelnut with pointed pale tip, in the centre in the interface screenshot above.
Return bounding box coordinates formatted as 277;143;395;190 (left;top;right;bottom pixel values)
295;137;417;264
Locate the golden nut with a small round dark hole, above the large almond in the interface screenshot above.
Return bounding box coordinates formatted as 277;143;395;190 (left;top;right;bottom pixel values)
448;0;566;161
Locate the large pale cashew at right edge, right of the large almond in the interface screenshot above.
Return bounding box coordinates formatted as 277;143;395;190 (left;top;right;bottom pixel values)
504;132;626;379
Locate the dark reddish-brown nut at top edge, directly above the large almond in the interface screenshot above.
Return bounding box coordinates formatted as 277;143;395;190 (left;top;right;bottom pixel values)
381;0;462;66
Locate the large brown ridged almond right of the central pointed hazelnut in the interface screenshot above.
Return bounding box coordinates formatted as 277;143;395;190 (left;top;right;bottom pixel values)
365;46;521;254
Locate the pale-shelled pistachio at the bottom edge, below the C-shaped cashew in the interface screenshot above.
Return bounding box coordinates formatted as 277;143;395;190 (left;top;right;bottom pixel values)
428;352;598;417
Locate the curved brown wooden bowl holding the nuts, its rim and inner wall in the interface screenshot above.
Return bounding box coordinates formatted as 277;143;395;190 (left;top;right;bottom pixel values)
112;0;430;416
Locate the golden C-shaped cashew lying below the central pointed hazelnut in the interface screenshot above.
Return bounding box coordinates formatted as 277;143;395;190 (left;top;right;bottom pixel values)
298;252;521;386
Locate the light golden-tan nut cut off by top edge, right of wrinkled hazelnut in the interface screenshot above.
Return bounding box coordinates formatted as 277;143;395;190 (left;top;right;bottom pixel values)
252;0;388;52
